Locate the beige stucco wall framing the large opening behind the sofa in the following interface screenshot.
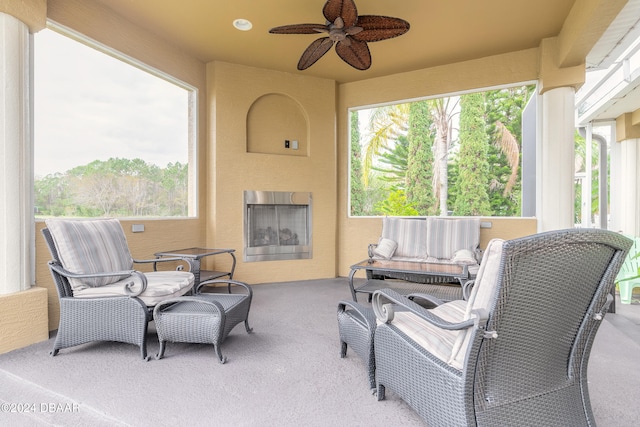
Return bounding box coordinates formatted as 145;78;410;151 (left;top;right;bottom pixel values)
336;48;540;276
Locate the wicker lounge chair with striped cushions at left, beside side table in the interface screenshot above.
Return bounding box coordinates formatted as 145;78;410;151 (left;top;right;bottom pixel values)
42;219;194;360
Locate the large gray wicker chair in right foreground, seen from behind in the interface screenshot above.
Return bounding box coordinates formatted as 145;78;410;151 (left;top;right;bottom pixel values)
373;229;631;426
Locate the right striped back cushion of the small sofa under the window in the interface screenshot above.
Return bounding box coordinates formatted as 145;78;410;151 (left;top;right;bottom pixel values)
427;217;480;259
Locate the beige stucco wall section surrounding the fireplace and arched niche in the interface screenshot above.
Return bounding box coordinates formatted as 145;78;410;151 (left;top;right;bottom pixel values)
207;62;337;283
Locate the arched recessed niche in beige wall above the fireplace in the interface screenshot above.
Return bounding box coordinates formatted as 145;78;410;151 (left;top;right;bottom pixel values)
247;93;309;156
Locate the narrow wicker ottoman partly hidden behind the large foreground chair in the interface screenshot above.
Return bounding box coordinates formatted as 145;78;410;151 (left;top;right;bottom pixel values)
338;301;376;391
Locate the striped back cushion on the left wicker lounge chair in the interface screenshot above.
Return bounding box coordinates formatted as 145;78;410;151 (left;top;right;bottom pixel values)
45;219;133;291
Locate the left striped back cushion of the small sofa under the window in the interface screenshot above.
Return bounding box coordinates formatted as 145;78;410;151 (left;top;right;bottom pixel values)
382;217;427;258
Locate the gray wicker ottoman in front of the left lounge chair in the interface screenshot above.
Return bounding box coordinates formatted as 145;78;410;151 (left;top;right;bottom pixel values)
153;284;252;363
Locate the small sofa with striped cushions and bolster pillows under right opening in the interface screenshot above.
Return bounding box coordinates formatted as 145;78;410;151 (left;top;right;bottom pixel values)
367;217;482;280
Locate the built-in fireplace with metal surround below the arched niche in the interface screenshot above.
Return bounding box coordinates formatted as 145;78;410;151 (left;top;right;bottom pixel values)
244;191;312;262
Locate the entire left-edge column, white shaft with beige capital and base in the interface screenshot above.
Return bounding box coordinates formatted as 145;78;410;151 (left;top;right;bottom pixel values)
0;0;49;353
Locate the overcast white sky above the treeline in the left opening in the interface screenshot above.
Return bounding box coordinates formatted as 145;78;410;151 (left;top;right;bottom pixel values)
34;30;188;177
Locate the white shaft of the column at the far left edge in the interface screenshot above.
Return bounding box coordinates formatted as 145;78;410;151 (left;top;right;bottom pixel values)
0;12;33;295
